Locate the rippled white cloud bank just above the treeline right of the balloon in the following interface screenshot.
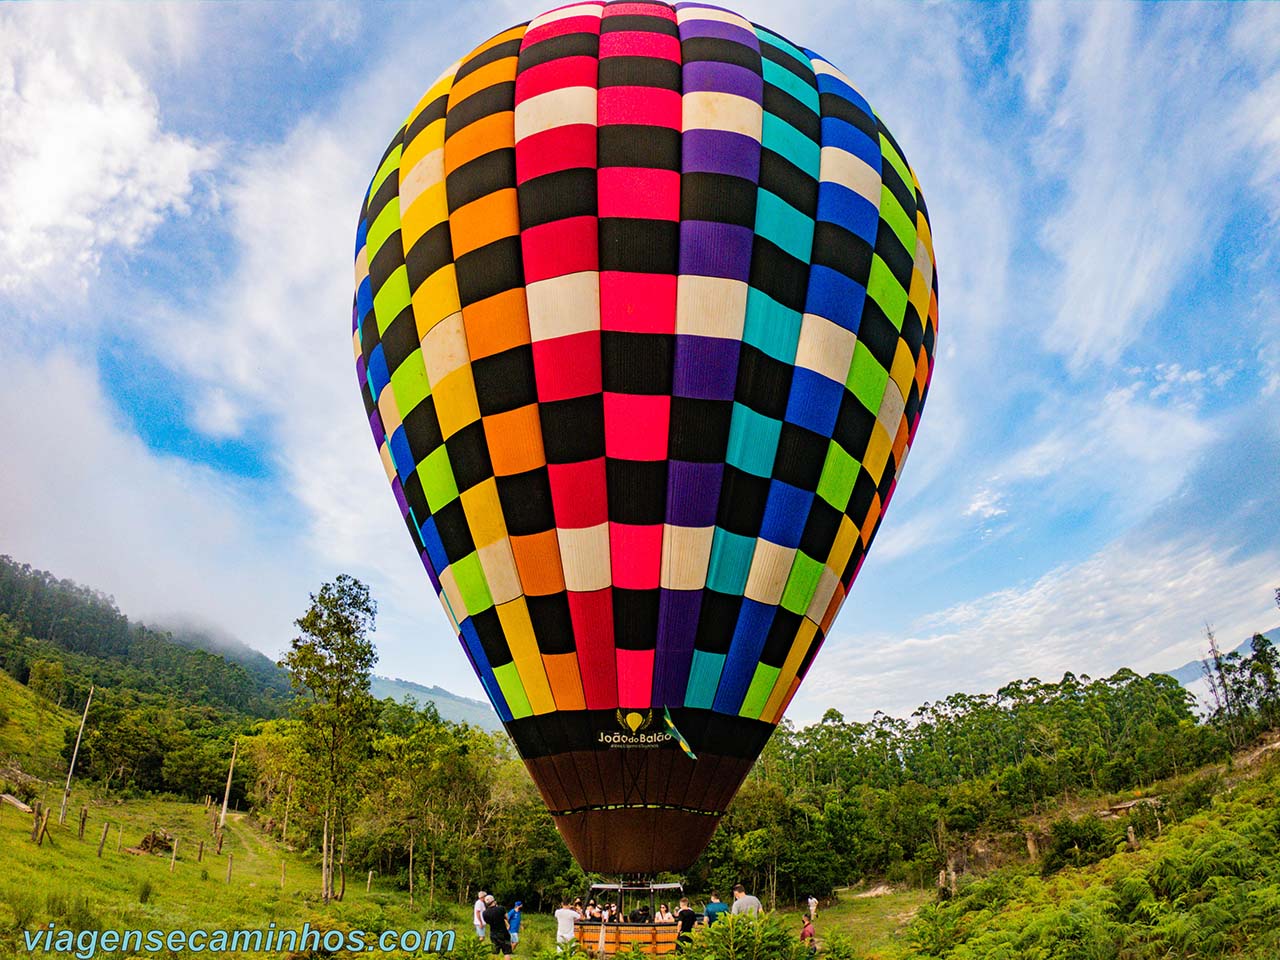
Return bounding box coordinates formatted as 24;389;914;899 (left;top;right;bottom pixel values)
792;538;1280;722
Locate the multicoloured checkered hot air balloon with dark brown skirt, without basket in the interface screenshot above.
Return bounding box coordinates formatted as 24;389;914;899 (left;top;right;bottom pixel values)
353;1;937;874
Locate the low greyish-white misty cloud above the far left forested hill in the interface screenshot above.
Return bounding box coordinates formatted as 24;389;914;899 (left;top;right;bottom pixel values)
0;351;312;652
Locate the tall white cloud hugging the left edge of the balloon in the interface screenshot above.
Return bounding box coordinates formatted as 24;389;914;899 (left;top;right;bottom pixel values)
131;38;479;695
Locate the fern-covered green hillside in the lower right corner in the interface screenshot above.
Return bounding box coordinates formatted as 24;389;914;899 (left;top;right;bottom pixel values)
865;750;1280;960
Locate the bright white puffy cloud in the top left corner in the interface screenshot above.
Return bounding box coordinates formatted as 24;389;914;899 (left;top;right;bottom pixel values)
0;6;216;292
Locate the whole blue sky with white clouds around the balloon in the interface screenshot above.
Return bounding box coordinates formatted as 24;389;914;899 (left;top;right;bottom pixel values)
0;0;1280;723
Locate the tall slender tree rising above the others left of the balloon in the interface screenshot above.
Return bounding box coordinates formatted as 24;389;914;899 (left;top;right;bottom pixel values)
280;573;378;904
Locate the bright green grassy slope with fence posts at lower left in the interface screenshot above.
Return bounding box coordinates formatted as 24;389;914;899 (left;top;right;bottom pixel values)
0;790;560;957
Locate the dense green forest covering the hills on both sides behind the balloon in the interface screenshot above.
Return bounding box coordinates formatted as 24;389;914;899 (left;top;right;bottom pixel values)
0;558;1280;957
